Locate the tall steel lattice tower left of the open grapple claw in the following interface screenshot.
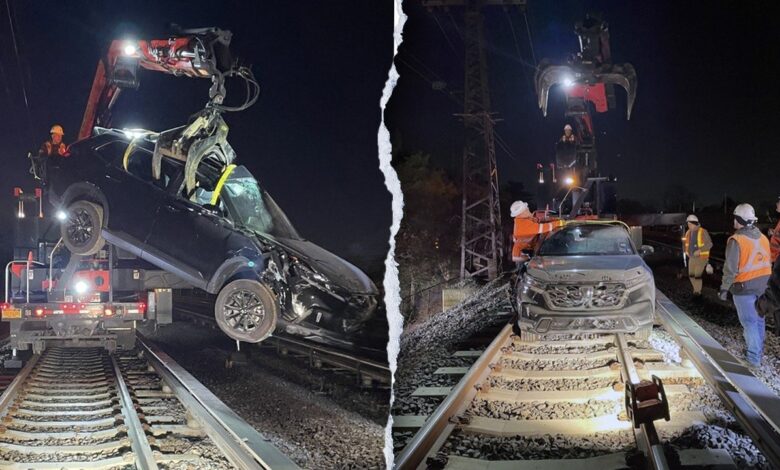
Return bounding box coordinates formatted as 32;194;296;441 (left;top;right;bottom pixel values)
422;0;526;280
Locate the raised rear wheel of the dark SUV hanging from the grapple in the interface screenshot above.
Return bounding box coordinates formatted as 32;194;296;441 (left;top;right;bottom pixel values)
60;201;106;255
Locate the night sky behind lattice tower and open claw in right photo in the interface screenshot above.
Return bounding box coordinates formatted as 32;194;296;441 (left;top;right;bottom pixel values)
389;0;780;212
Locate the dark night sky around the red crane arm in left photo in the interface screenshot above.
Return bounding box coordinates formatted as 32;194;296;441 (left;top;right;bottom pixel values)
0;0;393;271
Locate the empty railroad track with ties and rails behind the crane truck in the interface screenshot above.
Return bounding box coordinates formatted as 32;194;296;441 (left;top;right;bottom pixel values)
0;338;297;469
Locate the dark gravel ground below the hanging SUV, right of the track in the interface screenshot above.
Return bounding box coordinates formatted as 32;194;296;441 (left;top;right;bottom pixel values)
145;322;387;469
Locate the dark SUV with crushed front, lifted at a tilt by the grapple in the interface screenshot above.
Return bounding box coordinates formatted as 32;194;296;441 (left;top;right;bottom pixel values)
46;128;378;343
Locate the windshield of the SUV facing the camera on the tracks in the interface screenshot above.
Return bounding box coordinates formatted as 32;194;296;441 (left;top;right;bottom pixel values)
539;224;635;256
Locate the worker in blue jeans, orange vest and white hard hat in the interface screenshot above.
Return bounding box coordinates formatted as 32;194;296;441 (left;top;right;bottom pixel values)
719;204;772;367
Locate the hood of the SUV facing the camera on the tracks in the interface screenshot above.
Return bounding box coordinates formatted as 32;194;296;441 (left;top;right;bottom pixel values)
528;255;650;282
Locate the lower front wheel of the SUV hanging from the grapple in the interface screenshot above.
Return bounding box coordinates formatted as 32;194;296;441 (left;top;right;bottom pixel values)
214;279;279;343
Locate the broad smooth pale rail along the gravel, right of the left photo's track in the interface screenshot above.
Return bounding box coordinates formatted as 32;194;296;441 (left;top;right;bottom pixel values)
137;333;299;470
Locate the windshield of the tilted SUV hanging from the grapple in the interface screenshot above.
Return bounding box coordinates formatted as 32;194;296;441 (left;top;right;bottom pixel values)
220;166;300;239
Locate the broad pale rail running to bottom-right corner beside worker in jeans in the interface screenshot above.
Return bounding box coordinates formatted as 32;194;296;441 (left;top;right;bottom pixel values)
656;291;780;468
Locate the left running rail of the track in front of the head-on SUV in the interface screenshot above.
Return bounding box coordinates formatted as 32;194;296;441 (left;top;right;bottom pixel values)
395;323;512;470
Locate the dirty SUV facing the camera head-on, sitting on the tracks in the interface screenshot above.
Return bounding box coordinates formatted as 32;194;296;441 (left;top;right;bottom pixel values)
514;222;655;341
